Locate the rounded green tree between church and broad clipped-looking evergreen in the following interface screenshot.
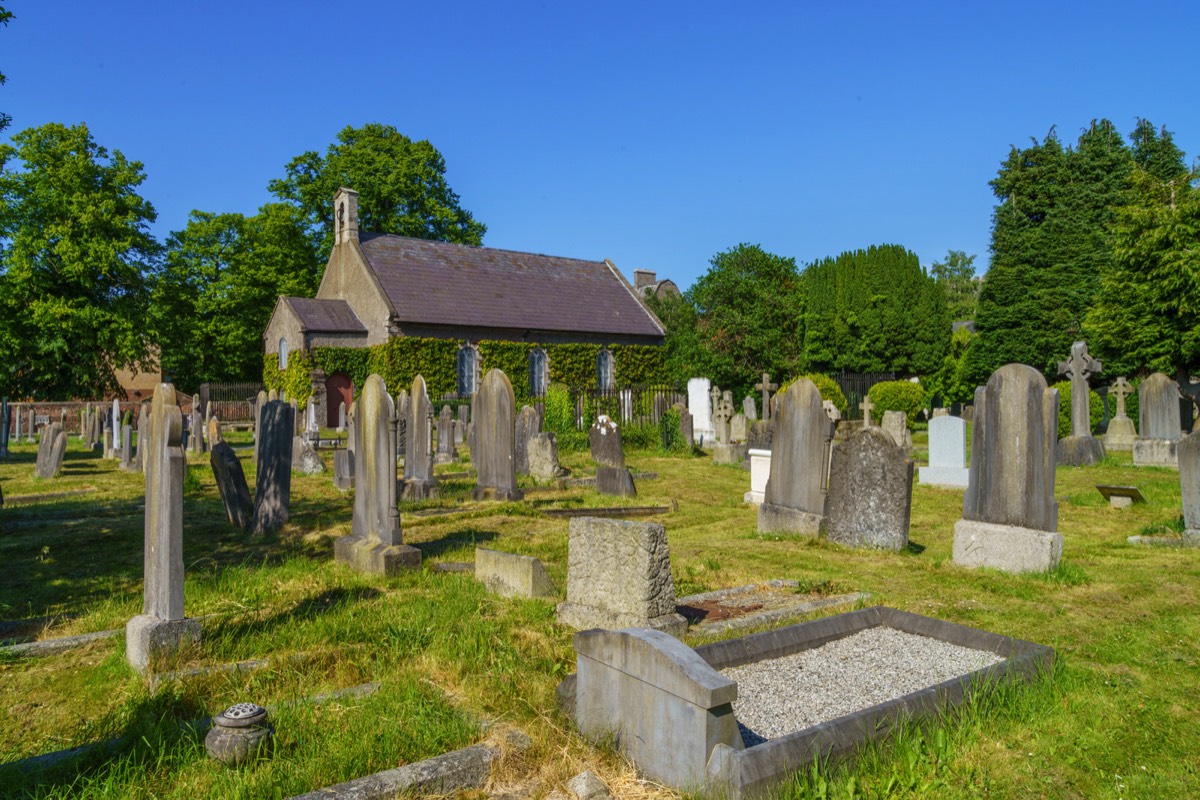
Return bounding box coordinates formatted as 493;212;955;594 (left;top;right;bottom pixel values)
686;243;804;396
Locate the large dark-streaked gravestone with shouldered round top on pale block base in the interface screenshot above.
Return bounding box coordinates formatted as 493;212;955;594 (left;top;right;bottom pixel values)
954;363;1062;572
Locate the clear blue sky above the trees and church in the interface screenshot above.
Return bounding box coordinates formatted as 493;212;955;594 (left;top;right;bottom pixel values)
0;0;1200;288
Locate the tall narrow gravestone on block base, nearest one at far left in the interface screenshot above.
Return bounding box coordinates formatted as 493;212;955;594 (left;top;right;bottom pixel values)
125;384;200;672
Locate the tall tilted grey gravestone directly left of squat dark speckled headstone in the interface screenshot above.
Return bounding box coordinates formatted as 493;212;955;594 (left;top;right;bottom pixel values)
758;378;833;536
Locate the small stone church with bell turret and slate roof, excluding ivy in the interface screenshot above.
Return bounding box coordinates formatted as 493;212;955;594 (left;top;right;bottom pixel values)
263;188;673;426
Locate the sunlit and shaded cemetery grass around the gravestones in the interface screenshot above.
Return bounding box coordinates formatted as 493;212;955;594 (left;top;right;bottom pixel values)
0;434;1200;798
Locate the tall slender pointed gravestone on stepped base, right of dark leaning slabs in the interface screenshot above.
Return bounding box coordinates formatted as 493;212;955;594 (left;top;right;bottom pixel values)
334;374;421;575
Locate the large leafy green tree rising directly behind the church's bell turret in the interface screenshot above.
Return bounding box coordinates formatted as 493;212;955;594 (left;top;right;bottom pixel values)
269;122;487;260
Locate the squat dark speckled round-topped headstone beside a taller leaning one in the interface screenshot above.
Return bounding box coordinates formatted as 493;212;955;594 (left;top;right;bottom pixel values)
826;428;912;552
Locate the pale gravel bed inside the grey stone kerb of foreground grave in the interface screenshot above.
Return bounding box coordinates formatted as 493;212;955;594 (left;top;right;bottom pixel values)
721;626;1003;747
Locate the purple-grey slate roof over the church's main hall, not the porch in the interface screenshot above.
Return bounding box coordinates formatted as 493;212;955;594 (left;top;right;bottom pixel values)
359;233;664;337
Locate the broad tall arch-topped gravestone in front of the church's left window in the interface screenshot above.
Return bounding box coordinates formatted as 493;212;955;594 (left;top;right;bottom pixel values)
470;369;524;500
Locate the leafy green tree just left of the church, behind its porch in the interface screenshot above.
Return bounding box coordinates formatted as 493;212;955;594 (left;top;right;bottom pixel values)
151;203;320;391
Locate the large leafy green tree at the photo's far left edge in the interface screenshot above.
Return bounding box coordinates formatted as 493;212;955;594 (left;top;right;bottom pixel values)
0;124;160;399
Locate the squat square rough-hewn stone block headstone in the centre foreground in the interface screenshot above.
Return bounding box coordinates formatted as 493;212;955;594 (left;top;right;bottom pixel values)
558;517;688;636
